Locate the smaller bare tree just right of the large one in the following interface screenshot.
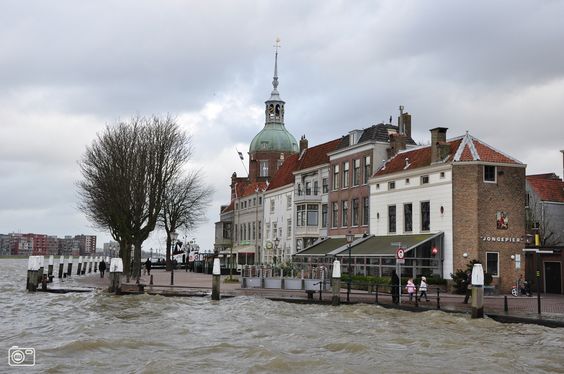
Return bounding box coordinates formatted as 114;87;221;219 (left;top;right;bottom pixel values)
160;171;214;270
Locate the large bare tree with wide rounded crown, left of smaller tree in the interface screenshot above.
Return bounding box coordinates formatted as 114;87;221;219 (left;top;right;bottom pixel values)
78;116;191;277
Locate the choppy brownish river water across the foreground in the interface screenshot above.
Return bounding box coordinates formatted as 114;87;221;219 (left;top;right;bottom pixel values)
0;259;564;374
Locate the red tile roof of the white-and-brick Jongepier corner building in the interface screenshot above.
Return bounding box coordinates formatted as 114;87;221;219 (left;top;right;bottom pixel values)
374;134;522;176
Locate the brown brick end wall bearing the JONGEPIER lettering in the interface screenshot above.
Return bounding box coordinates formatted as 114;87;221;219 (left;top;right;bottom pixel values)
453;164;525;293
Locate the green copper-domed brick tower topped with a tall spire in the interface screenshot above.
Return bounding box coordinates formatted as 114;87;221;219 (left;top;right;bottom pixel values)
249;40;298;180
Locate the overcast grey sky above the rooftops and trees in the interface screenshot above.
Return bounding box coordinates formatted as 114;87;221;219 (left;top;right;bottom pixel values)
0;0;564;254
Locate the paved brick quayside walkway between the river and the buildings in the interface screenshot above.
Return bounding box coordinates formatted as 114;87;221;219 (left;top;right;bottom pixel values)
75;269;564;326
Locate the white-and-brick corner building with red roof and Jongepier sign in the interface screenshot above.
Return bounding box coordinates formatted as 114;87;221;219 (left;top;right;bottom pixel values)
370;128;525;292
